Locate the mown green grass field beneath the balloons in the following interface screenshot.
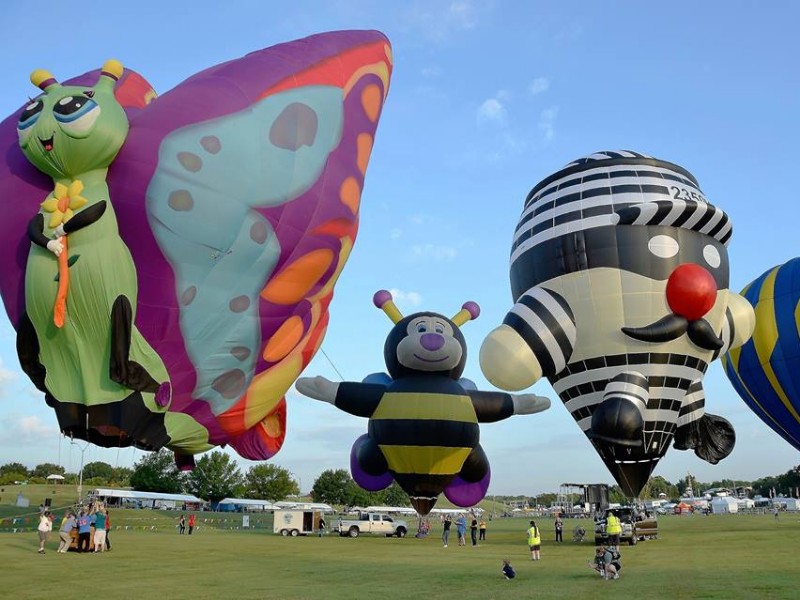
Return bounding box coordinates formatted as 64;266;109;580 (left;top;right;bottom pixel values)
0;486;800;600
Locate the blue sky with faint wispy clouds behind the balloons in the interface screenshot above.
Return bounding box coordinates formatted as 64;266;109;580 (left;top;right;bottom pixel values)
0;0;800;494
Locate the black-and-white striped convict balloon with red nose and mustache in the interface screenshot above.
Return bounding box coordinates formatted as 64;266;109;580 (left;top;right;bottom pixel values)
480;151;753;496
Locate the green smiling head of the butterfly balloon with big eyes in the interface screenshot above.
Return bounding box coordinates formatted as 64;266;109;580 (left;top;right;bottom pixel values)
17;71;128;178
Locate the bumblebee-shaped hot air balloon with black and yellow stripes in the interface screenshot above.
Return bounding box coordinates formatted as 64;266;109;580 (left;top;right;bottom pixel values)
296;290;550;515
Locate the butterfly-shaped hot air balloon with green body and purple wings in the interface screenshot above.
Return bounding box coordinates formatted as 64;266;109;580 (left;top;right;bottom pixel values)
0;31;391;466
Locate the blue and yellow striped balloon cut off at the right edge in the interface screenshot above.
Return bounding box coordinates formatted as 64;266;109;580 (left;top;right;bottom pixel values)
722;258;800;450
